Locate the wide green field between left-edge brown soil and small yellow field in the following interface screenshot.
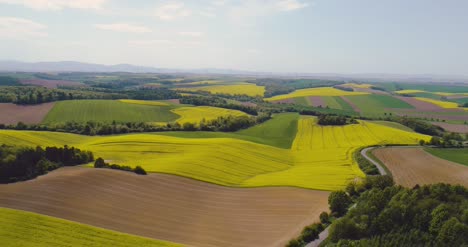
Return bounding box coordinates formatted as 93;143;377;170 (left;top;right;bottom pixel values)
43;100;180;124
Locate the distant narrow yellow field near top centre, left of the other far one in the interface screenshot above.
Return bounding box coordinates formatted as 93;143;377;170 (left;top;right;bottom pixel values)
179;83;265;97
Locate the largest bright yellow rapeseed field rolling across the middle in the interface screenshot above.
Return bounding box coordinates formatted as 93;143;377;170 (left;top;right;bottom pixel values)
0;117;430;190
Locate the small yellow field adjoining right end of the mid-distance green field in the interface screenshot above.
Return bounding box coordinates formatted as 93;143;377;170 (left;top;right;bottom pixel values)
171;106;248;124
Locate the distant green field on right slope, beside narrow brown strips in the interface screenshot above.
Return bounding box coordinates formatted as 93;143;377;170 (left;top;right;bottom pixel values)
346;94;414;113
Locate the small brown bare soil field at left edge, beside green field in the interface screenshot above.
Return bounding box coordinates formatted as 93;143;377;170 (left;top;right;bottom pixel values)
0;102;55;124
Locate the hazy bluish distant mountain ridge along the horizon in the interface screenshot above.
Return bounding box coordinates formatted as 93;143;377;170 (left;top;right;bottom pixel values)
0;60;468;83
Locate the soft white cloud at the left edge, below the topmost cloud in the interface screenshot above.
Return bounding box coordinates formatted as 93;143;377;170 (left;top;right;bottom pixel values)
0;17;47;39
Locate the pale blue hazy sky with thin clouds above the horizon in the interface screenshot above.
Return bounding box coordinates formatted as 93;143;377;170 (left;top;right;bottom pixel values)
0;0;468;76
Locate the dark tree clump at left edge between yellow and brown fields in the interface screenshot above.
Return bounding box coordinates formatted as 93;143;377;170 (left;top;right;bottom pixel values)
0;145;94;183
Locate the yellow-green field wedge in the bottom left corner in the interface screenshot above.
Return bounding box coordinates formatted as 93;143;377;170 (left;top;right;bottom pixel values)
0;208;182;247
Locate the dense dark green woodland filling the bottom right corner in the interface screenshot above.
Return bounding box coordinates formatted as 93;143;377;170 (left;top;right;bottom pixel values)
287;176;468;247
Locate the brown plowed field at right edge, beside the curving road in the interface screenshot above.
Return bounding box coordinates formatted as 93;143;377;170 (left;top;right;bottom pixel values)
373;147;468;187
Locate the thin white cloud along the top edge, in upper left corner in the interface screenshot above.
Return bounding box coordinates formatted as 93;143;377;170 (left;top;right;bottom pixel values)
0;0;107;10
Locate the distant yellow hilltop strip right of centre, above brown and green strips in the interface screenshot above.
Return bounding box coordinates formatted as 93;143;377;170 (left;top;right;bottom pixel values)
265;87;369;101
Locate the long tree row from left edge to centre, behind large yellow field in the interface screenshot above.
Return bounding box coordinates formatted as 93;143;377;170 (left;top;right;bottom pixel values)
0;113;271;136
